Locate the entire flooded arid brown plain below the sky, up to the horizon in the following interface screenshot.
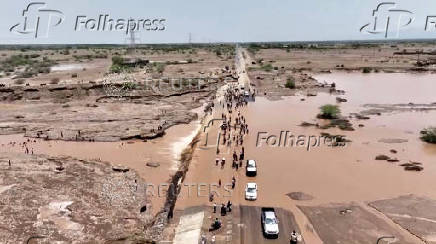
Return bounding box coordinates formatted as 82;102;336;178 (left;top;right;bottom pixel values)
0;42;436;244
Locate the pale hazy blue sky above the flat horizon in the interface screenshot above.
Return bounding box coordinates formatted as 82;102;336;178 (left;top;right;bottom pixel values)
0;0;436;44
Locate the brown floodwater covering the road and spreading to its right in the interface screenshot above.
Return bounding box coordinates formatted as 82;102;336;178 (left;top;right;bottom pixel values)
177;73;436;243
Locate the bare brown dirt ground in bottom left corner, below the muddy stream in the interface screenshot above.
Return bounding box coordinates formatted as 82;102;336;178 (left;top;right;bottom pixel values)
0;153;153;243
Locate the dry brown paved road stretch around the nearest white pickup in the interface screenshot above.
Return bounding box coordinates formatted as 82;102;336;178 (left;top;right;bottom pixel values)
233;206;304;244
